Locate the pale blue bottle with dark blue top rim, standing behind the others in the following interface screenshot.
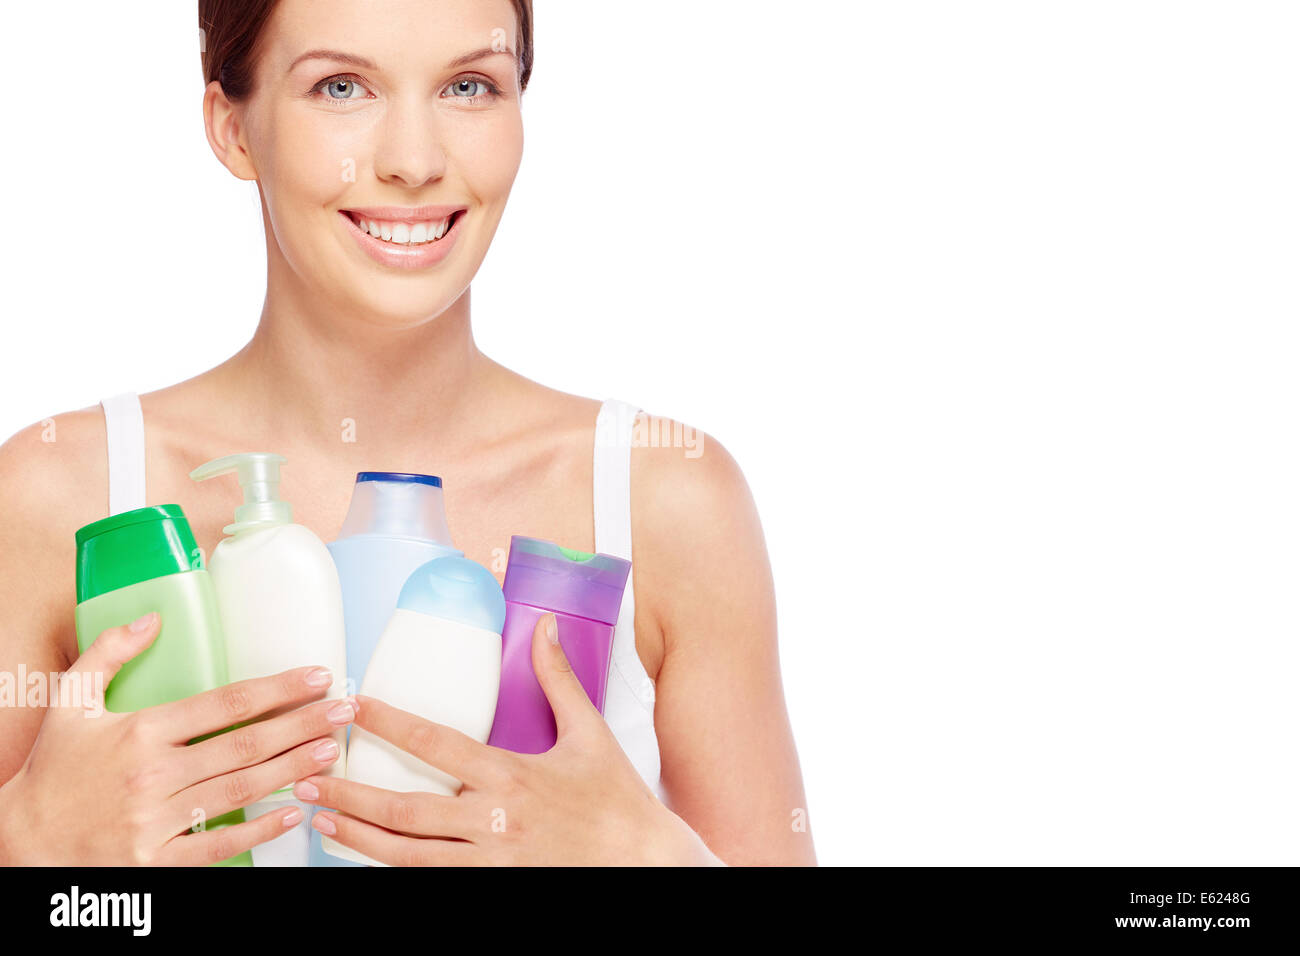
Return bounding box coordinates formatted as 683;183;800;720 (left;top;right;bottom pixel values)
311;471;463;866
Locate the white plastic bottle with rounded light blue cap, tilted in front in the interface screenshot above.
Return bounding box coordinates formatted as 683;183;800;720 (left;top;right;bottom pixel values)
322;558;506;862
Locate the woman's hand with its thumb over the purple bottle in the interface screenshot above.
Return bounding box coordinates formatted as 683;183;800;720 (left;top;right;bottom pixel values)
294;614;722;866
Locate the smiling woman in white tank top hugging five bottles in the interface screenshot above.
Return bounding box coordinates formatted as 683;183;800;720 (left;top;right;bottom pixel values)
0;0;815;864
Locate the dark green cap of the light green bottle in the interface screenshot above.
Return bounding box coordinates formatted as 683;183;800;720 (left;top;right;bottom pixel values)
77;505;203;604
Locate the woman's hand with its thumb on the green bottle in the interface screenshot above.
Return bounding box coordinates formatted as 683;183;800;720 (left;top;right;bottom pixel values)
0;614;356;866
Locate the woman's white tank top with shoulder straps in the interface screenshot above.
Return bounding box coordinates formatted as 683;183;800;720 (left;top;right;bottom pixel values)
100;392;664;801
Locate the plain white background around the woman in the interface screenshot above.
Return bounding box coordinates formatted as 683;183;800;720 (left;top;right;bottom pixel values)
0;0;1300;865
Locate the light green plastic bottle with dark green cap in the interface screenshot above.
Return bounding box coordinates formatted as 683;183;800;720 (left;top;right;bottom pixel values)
77;505;252;866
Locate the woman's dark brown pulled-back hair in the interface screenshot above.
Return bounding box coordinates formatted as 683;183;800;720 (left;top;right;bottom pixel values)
199;0;533;101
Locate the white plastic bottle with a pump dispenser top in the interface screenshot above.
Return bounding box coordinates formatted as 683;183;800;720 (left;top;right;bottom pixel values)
190;451;347;866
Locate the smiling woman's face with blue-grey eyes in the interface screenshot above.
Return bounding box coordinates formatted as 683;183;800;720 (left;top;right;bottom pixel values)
226;0;524;328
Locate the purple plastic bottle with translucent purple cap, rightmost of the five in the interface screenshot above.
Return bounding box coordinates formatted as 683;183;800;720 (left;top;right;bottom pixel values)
488;535;632;753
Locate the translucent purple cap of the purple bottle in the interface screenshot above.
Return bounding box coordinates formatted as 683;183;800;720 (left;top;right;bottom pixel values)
502;535;632;626
